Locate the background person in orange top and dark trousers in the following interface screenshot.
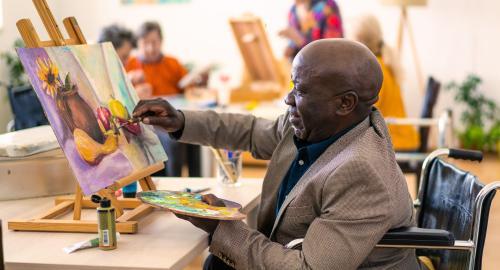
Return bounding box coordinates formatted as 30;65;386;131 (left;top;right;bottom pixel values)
125;22;201;177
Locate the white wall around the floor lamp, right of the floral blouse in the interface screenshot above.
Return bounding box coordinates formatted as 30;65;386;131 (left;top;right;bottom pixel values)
339;0;500;129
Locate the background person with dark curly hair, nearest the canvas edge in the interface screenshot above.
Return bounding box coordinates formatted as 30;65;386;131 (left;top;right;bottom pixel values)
98;24;152;98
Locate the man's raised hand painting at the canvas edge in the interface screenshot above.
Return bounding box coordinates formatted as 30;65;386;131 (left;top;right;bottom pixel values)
133;98;184;132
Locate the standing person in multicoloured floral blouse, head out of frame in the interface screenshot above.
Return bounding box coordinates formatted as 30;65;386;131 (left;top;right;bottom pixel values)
288;0;344;56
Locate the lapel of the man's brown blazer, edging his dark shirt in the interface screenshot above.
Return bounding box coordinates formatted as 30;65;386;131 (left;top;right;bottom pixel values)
269;117;370;238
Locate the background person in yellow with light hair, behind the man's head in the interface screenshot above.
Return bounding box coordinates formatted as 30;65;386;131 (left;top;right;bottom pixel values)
349;15;420;151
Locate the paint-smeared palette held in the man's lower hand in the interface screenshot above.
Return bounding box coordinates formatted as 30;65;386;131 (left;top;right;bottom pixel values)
137;190;246;220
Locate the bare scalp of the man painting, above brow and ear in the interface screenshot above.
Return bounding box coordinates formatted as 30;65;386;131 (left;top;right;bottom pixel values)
293;39;383;105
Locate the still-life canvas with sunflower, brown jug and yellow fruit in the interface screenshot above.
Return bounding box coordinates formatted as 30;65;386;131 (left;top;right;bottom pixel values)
17;43;167;195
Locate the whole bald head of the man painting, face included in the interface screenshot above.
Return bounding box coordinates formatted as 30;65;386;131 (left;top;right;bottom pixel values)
285;39;383;142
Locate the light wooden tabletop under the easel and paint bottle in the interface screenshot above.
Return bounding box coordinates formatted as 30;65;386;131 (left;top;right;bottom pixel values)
0;177;262;270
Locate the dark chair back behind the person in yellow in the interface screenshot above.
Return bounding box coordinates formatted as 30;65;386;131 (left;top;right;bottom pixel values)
418;76;441;153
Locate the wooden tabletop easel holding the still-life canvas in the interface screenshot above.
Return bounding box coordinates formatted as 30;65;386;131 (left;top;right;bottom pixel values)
8;0;164;233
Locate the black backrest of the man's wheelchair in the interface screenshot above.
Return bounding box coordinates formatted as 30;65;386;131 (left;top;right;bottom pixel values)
418;158;494;270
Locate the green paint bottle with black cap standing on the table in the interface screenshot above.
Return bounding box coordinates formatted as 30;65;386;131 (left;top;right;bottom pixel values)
92;195;117;250
